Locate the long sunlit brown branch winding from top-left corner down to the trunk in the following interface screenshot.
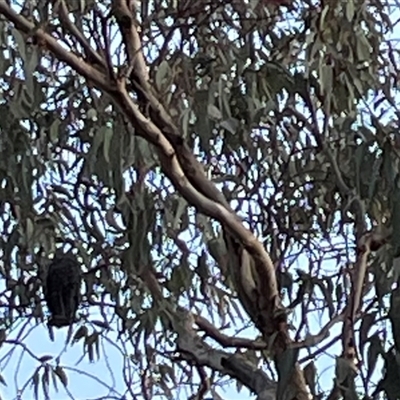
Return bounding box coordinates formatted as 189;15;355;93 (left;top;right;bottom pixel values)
0;0;278;306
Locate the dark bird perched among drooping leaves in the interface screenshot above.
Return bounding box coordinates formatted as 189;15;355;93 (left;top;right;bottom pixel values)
44;249;82;328
